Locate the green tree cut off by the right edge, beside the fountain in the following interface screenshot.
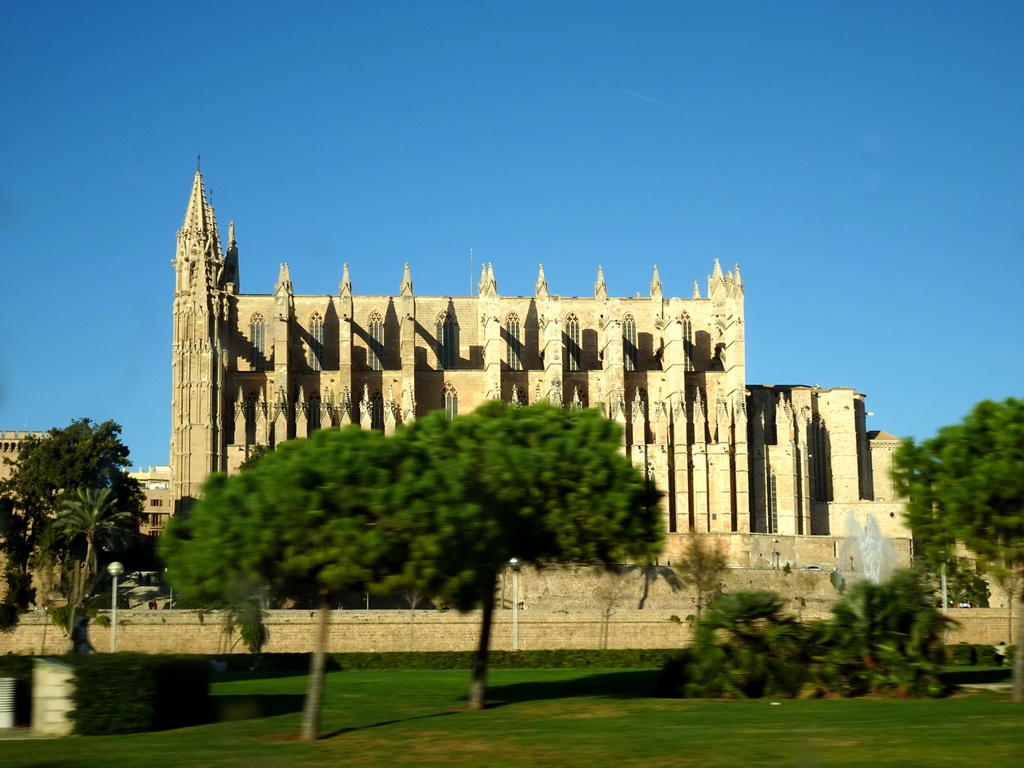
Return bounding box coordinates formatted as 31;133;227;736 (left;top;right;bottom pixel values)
894;398;1024;701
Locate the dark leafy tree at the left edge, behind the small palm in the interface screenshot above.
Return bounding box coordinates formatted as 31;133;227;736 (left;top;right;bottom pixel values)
0;419;144;607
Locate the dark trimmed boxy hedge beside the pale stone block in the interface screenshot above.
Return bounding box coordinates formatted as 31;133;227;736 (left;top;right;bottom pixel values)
66;653;210;736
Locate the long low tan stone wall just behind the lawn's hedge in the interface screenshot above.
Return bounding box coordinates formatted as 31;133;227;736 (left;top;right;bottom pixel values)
0;608;1012;654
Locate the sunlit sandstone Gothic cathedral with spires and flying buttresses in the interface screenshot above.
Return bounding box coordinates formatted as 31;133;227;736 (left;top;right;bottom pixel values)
170;172;909;565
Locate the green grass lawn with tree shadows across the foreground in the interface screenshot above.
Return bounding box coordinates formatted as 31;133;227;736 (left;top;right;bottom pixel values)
0;670;1024;768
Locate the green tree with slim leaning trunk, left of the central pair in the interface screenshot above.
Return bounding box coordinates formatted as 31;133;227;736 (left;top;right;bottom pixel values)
160;426;402;739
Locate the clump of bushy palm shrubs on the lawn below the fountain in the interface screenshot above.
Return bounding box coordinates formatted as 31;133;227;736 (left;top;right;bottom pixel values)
666;571;947;698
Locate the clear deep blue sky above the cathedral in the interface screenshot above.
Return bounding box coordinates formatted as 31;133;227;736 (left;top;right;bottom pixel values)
0;0;1024;466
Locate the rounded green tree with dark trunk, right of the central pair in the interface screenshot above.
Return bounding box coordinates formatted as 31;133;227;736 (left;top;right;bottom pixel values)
389;401;663;709
